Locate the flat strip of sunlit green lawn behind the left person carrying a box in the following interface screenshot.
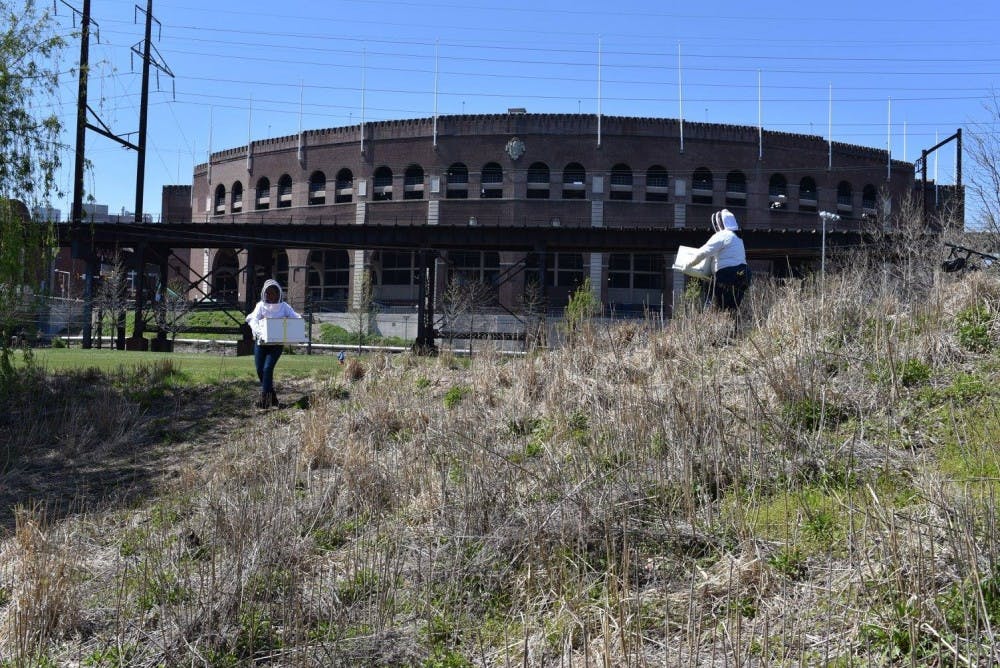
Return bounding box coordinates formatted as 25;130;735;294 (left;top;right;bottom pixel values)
15;348;340;384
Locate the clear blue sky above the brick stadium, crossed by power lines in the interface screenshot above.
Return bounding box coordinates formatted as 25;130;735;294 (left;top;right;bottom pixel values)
45;0;1000;224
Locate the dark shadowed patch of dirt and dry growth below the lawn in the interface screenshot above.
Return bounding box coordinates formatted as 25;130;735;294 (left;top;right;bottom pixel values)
0;379;314;540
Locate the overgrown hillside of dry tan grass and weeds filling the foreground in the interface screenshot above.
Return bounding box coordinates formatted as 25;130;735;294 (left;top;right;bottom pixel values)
0;237;1000;668
